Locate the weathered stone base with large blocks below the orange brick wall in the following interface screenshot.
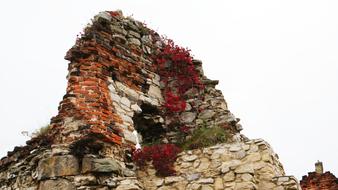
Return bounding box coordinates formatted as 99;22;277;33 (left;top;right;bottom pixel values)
0;145;143;190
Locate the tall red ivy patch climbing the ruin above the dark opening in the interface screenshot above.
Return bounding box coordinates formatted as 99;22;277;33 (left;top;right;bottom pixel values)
155;40;203;112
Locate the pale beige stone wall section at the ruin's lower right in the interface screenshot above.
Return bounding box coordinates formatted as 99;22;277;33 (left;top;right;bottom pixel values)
137;139;300;190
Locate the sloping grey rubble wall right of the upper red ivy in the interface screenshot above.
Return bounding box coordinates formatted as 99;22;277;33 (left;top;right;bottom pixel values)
165;59;240;143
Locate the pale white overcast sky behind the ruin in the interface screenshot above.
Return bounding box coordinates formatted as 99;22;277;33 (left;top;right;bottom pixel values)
0;0;338;179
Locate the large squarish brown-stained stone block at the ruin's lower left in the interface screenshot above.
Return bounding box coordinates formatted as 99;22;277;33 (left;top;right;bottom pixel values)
37;155;79;180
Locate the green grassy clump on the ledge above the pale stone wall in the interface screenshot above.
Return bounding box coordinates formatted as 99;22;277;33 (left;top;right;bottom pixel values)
181;126;229;150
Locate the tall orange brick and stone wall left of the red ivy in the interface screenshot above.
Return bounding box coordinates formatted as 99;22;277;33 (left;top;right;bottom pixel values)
52;12;163;144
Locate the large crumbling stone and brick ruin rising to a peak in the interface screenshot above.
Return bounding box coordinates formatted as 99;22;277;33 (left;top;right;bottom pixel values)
0;11;300;190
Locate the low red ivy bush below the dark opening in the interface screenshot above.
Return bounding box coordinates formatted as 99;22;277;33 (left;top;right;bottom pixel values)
133;144;180;176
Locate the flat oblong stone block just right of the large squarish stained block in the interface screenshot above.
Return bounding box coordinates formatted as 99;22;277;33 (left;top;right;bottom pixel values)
82;157;121;173
